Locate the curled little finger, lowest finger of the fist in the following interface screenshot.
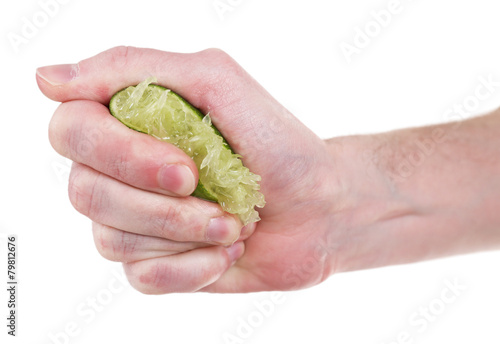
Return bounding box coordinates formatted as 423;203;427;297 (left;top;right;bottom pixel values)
124;242;244;294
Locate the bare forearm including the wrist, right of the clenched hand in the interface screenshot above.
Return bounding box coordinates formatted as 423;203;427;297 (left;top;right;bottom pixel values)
329;111;500;270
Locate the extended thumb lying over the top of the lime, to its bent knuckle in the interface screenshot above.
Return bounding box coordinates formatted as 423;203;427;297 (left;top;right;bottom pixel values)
37;47;256;110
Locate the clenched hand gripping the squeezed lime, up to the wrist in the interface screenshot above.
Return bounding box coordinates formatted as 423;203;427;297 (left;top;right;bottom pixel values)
37;47;342;294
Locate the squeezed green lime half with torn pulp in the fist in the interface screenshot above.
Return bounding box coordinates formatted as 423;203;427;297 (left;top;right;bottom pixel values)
109;78;265;225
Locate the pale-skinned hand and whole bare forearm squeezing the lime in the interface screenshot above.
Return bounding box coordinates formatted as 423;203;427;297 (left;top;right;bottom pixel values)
37;47;500;294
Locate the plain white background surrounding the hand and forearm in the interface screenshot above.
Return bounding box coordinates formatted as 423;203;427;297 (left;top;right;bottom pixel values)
0;0;500;344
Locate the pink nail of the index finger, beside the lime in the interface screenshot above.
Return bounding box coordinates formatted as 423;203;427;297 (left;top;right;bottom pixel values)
158;165;196;196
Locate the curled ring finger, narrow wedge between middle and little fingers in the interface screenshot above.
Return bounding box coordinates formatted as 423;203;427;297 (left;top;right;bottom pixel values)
92;222;209;263
